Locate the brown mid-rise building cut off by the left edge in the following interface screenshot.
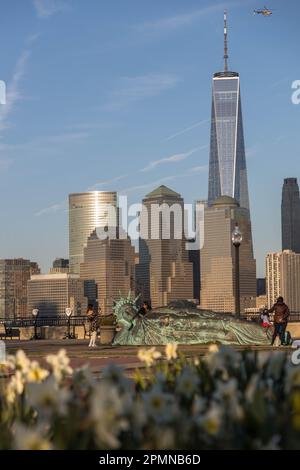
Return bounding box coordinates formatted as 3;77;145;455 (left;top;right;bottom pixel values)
0;258;40;320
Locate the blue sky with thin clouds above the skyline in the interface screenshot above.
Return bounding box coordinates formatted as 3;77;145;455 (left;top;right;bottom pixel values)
0;0;300;275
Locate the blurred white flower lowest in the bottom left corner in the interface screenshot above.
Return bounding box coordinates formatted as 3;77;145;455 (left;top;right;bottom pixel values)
14;424;52;450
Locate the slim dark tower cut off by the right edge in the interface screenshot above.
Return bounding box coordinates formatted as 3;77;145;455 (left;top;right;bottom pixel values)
281;178;300;253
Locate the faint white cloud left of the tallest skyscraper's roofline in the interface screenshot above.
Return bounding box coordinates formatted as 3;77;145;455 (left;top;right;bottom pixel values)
102;73;180;111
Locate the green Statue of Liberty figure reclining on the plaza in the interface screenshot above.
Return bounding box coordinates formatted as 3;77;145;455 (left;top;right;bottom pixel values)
113;293;272;345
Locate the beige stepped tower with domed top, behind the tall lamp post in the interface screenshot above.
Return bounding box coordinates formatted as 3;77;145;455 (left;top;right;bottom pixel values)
200;196;256;312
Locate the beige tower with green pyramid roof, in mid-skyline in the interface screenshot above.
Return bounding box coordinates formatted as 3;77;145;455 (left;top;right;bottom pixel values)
137;186;193;307
